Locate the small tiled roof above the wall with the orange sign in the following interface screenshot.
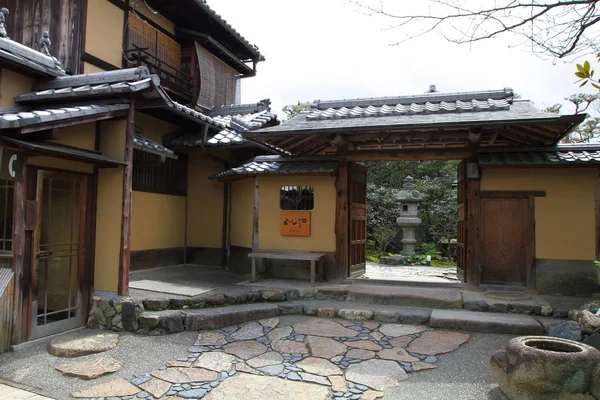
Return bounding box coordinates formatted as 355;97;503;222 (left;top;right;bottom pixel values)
210;156;338;179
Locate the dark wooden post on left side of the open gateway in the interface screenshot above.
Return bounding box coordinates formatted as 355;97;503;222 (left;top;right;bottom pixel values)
335;159;349;279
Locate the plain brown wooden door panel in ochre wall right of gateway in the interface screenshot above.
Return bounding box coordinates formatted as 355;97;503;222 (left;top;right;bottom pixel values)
481;198;533;286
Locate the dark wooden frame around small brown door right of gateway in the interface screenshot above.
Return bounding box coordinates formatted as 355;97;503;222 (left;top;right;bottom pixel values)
479;190;546;290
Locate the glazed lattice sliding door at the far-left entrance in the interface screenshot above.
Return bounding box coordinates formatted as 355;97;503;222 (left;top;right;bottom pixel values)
31;171;87;339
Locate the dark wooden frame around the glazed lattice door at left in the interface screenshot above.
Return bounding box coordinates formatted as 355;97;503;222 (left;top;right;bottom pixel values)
21;165;97;342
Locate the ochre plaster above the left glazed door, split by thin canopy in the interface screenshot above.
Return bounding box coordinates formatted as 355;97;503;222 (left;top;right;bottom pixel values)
27;122;96;174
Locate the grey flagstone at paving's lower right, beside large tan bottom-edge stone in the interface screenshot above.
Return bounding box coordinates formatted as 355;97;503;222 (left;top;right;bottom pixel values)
346;360;408;391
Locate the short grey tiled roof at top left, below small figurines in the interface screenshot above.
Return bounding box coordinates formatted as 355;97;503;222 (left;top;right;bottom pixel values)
0;37;65;76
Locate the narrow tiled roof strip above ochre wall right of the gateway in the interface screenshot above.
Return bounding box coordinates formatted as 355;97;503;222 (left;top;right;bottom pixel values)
477;145;600;166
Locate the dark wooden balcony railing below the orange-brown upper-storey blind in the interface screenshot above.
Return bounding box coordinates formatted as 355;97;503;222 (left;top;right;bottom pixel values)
124;45;194;101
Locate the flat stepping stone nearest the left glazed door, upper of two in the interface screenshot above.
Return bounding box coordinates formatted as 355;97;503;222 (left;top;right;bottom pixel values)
48;332;119;357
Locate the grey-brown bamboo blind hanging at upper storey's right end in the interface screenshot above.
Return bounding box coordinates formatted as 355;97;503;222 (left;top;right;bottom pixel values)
196;43;238;108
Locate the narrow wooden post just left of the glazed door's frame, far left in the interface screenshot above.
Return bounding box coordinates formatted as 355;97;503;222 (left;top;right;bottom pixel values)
11;159;26;344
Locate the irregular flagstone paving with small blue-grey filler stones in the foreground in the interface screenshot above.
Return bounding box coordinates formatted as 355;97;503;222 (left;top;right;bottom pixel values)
65;316;469;400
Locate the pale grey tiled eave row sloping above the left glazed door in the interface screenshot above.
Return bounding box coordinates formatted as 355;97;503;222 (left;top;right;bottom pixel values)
0;103;129;129
